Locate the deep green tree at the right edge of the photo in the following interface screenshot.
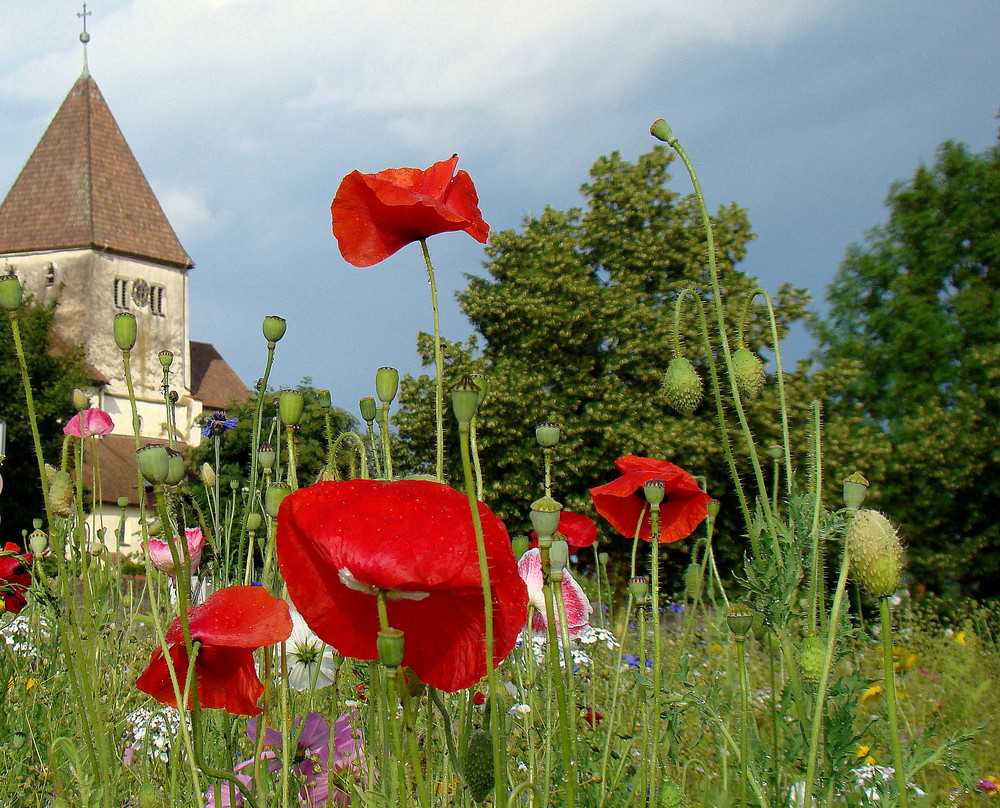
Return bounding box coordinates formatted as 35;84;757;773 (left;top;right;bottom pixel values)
817;142;1000;595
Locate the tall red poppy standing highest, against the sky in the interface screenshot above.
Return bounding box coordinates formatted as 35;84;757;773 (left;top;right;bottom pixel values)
330;154;490;267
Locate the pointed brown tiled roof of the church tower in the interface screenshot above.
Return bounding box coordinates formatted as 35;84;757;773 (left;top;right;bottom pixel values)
0;70;194;268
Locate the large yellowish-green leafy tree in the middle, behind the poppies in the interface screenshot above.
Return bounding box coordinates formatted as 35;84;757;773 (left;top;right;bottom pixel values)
397;148;840;580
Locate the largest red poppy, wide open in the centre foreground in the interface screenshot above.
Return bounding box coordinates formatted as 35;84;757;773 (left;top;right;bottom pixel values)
277;480;528;692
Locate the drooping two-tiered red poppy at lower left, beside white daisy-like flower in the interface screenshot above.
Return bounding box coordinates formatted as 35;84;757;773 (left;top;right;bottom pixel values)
135;586;292;715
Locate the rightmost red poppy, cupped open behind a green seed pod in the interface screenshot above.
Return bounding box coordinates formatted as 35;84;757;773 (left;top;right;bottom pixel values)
590;455;711;544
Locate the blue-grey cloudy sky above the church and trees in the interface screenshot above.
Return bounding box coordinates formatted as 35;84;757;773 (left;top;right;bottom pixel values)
0;0;1000;409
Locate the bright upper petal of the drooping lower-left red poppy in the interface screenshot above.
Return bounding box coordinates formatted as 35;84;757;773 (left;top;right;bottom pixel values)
183;586;292;648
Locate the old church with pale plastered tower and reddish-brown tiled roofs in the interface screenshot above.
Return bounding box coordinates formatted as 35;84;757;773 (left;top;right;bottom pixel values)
0;60;248;552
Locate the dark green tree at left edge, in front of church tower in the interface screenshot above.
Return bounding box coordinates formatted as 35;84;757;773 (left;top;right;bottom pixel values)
0;298;90;545
